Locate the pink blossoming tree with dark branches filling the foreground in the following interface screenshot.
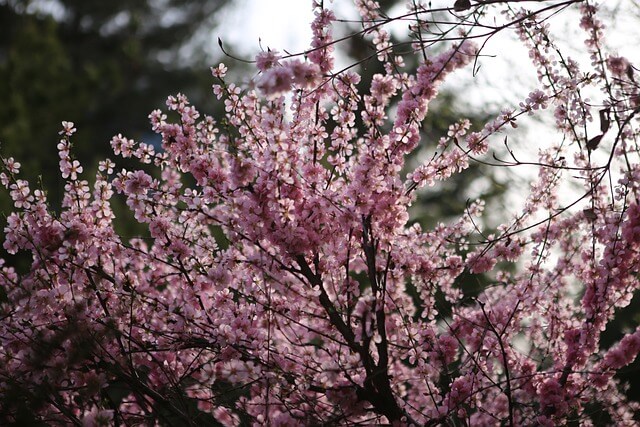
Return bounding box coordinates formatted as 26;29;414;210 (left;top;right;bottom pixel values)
0;0;640;426
